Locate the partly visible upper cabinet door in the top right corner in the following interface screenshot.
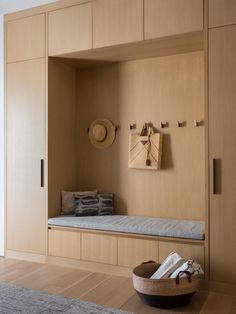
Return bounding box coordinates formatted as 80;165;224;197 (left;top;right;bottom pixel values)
209;0;236;27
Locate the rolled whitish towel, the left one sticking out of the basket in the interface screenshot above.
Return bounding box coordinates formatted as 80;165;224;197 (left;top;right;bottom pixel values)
150;252;185;279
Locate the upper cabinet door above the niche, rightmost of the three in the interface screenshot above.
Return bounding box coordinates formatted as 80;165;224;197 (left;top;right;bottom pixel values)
144;0;203;39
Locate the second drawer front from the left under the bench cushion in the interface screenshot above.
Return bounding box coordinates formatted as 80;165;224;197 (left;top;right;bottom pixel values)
81;233;117;265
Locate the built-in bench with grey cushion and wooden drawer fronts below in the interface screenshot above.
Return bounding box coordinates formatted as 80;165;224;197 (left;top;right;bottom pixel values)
48;215;205;271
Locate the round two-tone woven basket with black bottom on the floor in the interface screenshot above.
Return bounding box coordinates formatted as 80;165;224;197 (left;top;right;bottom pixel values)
133;262;199;308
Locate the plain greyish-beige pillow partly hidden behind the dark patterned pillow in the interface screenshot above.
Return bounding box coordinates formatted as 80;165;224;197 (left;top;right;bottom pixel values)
61;190;98;215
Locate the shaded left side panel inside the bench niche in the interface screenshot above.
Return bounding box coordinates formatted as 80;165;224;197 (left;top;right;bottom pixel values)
48;58;76;217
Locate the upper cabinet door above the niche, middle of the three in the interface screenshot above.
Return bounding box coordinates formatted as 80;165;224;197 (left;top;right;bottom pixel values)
93;0;143;48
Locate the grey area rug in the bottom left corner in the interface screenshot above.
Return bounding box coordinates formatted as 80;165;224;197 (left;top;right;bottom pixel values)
0;283;133;314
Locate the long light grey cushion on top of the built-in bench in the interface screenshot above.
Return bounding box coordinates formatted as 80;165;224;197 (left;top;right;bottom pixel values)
48;215;205;240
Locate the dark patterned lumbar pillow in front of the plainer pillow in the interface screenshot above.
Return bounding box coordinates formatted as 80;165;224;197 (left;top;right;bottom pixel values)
75;194;113;216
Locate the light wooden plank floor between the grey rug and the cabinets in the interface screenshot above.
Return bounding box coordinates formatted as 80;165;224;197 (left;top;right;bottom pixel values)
0;258;236;314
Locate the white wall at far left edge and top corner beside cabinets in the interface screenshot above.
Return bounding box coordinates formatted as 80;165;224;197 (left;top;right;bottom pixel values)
0;0;56;255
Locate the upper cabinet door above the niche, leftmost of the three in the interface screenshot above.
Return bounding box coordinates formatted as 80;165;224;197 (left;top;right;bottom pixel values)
48;3;92;56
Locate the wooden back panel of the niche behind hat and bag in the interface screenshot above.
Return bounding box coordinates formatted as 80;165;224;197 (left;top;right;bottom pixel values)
77;52;205;219
